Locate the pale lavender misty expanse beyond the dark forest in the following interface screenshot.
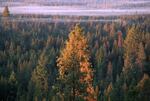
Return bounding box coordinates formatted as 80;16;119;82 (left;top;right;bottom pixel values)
0;0;150;15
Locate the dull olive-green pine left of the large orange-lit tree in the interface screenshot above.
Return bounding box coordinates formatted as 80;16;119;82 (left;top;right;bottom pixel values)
29;54;48;100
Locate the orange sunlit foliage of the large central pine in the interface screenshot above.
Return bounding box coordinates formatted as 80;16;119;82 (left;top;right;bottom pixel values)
57;25;94;101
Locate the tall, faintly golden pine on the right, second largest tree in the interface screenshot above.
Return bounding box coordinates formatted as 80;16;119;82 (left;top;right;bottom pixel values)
123;26;145;98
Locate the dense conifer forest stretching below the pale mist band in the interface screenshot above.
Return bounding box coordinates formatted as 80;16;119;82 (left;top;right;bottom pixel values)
0;14;150;101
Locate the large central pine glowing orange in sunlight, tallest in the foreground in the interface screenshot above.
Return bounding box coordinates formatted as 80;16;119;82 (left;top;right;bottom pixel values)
57;25;94;101
